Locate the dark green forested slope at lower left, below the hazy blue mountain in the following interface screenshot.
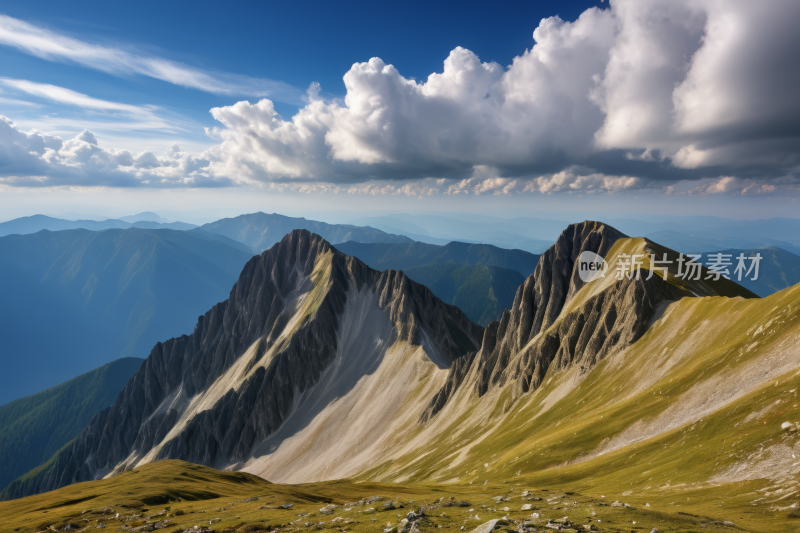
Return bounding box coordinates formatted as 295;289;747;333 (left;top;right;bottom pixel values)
0;357;143;488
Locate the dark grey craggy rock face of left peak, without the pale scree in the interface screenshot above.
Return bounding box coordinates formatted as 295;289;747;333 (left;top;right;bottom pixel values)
4;230;483;498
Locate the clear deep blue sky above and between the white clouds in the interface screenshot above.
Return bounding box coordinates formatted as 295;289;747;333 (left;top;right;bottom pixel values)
0;1;601;148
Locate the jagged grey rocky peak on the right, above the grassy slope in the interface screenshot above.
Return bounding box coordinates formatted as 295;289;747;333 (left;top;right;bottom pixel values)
421;221;756;422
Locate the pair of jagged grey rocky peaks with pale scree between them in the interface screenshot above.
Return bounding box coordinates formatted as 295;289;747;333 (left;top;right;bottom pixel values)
0;222;756;497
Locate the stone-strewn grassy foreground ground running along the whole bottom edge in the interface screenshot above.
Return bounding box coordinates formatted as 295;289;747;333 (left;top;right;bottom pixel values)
0;460;800;533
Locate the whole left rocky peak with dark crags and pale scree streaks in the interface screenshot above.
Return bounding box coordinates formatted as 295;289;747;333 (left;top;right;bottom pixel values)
7;230;483;496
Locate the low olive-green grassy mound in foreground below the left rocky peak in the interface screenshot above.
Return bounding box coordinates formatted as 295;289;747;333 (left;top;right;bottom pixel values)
0;460;768;533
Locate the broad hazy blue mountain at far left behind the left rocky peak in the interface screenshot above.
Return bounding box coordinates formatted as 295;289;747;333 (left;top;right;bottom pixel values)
0;228;252;404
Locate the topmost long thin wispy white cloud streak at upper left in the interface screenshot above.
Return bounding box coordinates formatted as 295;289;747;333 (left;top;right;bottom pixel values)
0;14;303;104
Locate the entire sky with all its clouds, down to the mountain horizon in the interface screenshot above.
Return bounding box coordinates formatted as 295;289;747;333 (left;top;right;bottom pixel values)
0;0;800;221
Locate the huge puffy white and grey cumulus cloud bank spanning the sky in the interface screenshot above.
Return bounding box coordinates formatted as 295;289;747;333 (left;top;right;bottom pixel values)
0;0;800;195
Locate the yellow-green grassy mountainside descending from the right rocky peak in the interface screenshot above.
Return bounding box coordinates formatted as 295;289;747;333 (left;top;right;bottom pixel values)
360;287;800;531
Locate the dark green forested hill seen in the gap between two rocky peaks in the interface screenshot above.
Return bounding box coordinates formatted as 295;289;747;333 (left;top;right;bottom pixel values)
405;262;525;326
